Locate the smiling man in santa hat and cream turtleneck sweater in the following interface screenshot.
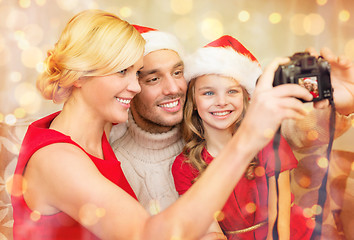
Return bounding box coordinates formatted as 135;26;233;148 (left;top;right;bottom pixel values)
111;26;187;214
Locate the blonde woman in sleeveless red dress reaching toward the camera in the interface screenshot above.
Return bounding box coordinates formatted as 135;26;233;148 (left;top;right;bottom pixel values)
12;10;311;239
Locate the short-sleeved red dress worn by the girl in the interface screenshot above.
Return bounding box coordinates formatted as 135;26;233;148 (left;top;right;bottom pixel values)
172;138;297;240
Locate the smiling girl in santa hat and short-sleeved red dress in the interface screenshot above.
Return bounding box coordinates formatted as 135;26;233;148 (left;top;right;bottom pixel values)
172;36;311;240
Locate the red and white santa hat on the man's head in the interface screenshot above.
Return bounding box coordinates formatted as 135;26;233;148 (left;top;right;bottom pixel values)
133;25;184;58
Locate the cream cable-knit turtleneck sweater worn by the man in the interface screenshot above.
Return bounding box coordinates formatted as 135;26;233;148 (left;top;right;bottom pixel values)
110;112;184;214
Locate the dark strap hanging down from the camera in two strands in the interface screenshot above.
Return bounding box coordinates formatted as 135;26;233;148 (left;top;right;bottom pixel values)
272;99;336;240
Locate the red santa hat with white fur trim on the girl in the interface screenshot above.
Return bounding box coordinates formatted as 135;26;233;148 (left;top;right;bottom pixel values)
184;35;262;95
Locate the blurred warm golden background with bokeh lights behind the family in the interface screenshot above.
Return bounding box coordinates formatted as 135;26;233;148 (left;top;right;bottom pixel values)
0;0;354;240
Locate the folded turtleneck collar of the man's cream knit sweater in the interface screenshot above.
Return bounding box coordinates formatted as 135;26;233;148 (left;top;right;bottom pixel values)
128;111;181;149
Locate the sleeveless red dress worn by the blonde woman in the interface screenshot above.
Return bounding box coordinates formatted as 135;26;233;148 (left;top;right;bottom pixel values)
11;112;136;240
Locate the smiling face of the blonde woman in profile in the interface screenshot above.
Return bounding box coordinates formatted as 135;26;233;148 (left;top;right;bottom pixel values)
79;57;143;123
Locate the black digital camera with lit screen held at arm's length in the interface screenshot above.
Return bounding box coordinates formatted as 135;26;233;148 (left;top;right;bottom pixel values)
273;52;333;101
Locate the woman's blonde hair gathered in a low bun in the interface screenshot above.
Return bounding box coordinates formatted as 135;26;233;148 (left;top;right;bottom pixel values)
37;10;145;103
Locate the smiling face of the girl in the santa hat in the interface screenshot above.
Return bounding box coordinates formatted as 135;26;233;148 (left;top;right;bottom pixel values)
194;74;244;131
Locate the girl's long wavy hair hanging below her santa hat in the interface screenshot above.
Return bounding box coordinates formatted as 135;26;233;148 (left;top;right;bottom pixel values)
182;78;257;181
